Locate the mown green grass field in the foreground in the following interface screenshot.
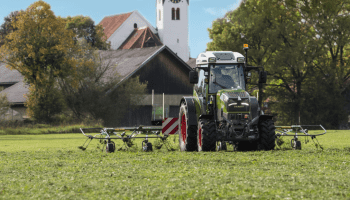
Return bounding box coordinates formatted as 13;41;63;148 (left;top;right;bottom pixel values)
0;131;350;199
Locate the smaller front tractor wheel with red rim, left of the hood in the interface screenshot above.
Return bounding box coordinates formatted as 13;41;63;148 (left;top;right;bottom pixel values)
197;120;216;151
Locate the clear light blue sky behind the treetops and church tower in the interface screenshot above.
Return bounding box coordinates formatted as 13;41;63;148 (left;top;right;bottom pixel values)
0;0;240;58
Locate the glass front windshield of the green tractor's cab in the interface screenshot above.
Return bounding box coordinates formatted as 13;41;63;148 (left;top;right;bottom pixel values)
209;64;245;93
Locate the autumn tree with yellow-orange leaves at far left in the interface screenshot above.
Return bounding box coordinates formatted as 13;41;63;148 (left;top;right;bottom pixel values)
0;1;78;121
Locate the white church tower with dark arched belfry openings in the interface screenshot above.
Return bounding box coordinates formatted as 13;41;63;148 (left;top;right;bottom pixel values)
156;0;189;62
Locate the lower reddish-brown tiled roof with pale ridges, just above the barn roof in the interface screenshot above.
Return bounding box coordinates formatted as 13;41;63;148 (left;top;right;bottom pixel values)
118;27;163;49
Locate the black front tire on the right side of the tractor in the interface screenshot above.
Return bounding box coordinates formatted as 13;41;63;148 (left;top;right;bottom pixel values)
258;119;276;151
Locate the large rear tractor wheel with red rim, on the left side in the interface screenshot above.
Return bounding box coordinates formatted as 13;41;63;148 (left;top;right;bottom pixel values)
179;102;197;151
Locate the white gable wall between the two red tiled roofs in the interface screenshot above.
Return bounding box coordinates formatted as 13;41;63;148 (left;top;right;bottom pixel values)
107;11;156;50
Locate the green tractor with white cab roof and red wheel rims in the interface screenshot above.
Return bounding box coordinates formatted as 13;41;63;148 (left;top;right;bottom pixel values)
179;45;275;151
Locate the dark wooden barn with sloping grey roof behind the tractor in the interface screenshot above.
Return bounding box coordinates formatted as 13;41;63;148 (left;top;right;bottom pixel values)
102;45;193;126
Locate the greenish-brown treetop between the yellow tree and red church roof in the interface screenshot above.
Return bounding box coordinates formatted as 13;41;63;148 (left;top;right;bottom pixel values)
65;16;110;50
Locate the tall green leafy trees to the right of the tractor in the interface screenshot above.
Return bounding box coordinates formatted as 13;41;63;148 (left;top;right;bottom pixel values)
207;0;350;128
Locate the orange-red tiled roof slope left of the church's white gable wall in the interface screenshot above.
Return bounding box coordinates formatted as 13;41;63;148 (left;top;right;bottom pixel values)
99;12;132;39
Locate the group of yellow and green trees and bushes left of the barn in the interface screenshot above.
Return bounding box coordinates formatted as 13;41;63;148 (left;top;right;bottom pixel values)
0;0;146;125
